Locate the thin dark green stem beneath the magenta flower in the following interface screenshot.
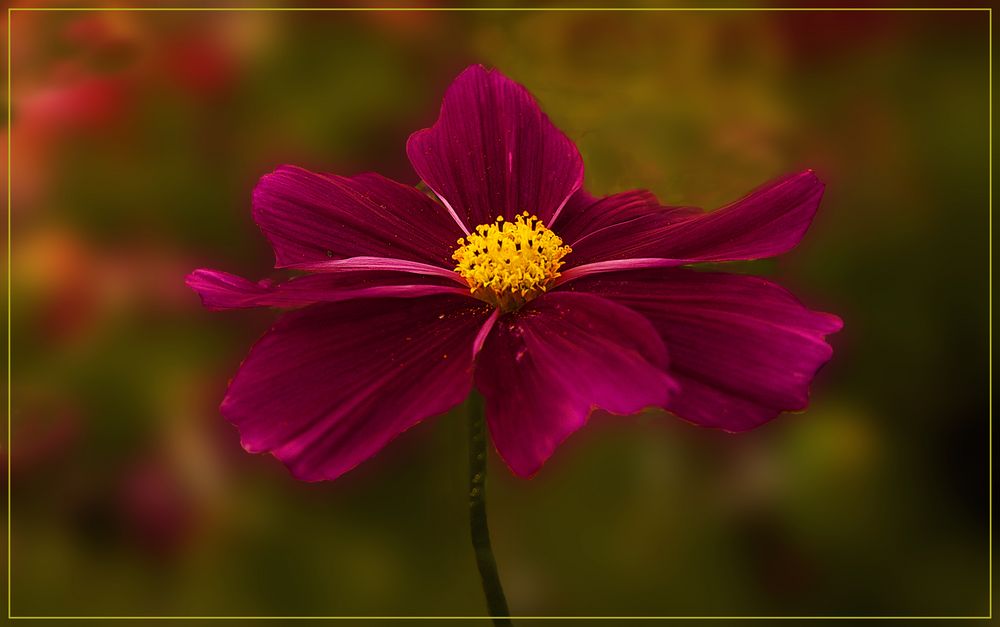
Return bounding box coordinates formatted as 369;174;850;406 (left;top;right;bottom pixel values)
467;392;511;625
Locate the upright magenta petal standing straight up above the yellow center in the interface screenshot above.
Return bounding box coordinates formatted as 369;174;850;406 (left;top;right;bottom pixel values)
406;65;583;231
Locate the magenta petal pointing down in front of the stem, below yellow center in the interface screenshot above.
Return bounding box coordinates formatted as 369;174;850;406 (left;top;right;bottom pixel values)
476;292;674;477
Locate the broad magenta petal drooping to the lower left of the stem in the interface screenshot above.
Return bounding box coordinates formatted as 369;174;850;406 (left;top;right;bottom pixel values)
222;296;491;481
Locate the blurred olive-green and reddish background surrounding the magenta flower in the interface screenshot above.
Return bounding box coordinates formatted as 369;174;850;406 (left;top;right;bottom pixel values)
0;2;989;615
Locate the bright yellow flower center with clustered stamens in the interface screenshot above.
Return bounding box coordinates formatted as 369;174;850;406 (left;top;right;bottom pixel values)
452;211;570;312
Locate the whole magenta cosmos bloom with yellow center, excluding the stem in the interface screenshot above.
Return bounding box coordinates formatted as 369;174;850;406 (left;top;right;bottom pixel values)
187;65;841;481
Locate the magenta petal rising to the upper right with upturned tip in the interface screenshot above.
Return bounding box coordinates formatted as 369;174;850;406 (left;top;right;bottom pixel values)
556;170;823;276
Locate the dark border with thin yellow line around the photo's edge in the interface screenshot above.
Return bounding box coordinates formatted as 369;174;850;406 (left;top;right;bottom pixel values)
6;7;993;620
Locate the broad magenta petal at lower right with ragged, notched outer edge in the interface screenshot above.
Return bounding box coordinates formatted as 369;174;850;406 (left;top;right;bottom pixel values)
570;268;842;431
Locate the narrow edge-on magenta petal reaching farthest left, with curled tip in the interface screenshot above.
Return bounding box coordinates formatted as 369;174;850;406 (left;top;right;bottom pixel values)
185;269;470;310
